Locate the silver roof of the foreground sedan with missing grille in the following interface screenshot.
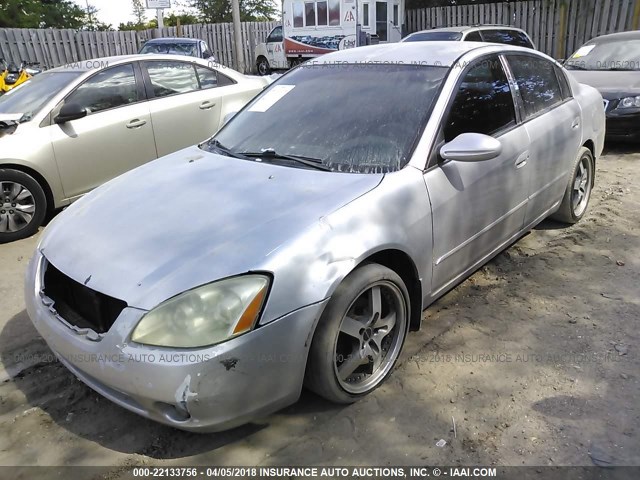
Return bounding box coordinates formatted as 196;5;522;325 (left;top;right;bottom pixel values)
316;41;529;67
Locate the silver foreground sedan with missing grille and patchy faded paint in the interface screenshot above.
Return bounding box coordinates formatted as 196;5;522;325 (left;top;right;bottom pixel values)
25;42;604;431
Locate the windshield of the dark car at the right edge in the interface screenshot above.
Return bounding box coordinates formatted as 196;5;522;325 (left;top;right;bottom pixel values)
565;39;640;71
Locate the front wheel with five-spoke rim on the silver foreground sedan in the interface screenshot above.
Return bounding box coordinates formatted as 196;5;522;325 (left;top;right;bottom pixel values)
305;263;411;404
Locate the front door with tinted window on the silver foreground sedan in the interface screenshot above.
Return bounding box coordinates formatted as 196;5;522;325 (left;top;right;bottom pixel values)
425;56;529;296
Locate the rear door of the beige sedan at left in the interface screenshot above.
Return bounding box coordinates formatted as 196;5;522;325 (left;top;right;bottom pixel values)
143;60;226;156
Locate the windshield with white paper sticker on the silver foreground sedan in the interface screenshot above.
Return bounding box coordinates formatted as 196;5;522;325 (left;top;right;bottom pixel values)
204;64;448;173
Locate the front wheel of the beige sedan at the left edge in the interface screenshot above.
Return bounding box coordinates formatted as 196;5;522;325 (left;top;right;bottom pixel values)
0;169;47;243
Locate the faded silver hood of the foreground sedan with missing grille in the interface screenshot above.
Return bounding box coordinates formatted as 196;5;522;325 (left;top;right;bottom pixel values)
39;147;383;310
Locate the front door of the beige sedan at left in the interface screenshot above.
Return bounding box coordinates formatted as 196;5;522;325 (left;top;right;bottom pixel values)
44;63;157;198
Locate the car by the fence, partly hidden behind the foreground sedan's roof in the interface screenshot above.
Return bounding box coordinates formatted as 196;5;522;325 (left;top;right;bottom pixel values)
401;25;536;49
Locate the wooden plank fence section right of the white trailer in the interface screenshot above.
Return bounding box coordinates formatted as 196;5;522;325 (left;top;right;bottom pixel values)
405;0;640;58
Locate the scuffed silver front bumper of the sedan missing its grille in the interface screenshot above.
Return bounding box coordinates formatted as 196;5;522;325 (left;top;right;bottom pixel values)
25;252;326;432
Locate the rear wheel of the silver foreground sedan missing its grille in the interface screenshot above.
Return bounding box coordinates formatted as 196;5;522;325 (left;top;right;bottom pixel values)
551;147;595;225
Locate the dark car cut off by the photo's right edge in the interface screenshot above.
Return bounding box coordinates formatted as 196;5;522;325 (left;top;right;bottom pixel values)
565;31;640;142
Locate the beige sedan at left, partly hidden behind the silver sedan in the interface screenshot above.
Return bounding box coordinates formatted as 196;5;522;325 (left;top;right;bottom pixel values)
0;55;269;243
